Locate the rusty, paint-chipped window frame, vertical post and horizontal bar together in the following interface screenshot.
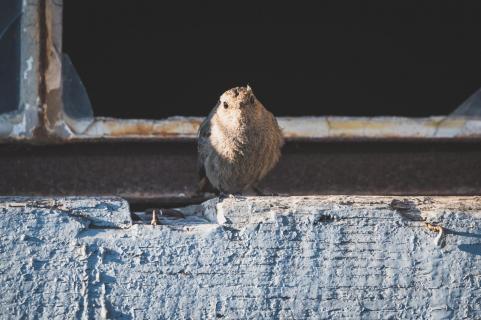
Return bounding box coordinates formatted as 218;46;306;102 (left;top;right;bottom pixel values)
0;0;481;143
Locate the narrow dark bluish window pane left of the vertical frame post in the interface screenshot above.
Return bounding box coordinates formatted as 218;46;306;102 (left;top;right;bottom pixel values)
0;0;22;113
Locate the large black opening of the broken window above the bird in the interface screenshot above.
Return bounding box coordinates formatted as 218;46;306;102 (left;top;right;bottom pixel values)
64;0;481;118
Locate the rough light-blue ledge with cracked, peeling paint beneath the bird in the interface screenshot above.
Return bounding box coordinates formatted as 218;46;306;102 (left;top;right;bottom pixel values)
0;196;481;319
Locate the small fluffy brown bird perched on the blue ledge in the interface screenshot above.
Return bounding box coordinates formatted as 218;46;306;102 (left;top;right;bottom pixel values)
198;86;284;194
